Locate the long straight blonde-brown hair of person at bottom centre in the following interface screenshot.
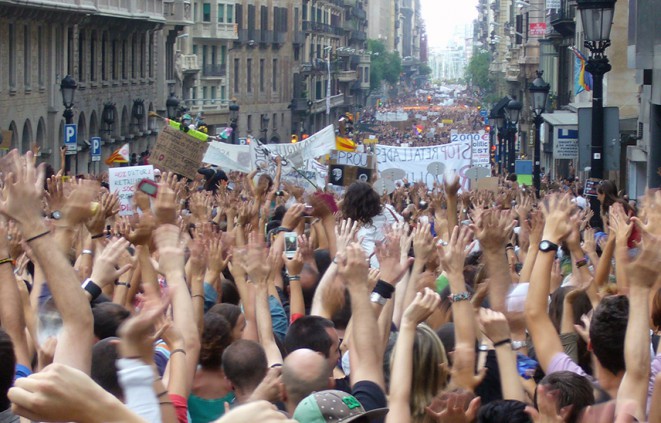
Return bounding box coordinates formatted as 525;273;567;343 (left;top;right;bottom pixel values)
390;324;448;422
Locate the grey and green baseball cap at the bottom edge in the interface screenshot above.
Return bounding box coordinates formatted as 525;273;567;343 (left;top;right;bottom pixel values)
293;389;388;423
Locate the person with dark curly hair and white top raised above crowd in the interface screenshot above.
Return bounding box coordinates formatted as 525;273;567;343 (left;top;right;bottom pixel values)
342;182;404;268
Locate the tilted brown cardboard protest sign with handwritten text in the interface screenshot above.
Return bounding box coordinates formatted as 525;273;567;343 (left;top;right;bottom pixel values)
150;126;209;179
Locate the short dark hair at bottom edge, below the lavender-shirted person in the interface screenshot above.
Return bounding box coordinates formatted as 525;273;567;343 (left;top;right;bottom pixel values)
535;371;594;423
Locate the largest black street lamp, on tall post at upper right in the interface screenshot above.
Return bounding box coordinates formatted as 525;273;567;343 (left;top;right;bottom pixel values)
576;0;616;179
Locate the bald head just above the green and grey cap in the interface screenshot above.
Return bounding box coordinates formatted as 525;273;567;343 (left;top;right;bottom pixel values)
282;348;332;411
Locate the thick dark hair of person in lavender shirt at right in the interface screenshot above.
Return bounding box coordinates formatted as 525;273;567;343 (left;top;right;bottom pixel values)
590;295;629;375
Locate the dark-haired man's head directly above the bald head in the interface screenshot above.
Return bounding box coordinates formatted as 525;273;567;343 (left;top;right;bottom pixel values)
285;316;340;370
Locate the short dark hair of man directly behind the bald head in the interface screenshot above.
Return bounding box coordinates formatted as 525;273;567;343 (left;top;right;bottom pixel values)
285;316;334;358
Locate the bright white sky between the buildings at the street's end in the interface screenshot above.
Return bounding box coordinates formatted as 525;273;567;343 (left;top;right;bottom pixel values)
420;0;478;47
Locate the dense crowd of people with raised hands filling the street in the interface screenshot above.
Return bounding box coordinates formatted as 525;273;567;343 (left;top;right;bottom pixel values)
0;93;661;423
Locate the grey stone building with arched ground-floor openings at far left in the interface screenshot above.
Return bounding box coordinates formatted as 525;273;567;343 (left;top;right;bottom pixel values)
0;0;177;173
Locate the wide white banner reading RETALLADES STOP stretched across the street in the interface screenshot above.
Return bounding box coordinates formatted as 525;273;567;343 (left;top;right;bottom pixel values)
376;141;471;189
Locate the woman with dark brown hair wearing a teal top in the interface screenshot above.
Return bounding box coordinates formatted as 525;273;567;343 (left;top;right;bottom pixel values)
188;313;234;423
